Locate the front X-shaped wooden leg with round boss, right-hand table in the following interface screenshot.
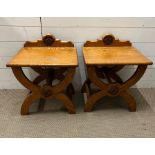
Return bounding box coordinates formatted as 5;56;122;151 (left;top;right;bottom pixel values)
85;65;147;112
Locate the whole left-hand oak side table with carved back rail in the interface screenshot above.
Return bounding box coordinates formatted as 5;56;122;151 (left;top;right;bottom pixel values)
7;35;78;115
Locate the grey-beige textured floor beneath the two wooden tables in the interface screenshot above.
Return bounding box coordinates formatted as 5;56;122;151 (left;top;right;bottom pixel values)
0;89;155;137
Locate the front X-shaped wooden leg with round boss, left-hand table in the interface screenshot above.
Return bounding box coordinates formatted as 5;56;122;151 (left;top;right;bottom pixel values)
12;67;76;115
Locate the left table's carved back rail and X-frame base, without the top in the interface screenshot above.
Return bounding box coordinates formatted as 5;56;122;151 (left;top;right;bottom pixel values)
7;35;76;115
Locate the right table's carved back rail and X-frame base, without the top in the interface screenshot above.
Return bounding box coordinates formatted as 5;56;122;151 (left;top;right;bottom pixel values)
81;35;152;112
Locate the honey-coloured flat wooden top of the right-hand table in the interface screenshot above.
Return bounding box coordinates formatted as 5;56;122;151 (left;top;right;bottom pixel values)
83;46;153;65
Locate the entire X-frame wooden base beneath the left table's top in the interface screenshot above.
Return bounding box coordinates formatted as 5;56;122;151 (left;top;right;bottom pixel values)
11;67;76;115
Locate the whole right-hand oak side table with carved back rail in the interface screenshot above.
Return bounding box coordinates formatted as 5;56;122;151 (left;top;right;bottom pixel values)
82;35;153;112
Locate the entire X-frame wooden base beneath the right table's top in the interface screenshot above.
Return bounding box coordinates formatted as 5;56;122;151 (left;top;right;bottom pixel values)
82;65;147;112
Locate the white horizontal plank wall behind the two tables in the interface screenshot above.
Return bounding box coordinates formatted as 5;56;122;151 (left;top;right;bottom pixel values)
0;18;155;90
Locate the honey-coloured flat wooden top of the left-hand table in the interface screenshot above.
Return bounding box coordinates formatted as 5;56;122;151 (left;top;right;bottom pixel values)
7;47;78;67
